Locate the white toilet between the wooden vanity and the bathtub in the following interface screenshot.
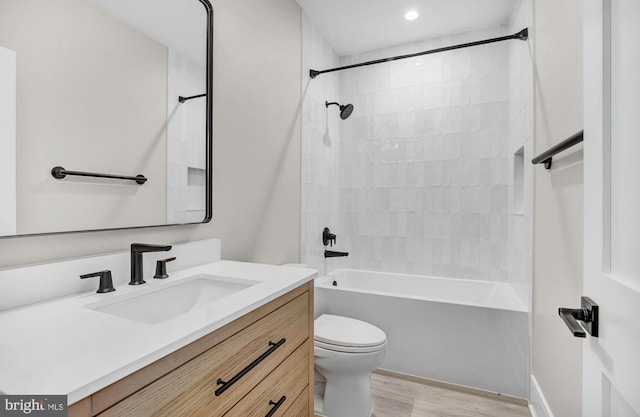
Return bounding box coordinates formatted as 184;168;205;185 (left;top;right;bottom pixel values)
314;314;387;417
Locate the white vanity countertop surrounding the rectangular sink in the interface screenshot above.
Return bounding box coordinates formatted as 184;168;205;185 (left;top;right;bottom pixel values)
0;261;317;404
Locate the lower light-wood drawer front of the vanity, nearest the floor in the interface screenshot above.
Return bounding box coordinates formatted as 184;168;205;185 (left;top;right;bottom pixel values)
222;340;309;417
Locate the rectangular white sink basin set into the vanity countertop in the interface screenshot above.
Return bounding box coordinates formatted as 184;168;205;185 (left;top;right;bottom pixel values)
85;274;258;324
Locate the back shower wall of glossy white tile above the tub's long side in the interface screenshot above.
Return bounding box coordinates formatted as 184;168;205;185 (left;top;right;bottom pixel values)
340;27;509;281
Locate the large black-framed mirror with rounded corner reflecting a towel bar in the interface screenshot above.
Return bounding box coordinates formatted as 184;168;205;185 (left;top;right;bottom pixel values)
0;0;213;237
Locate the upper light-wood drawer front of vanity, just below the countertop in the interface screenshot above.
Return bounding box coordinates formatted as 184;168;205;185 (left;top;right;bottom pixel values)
100;293;309;417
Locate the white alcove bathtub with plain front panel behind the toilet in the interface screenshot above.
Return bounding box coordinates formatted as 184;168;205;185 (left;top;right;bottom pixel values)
315;269;529;398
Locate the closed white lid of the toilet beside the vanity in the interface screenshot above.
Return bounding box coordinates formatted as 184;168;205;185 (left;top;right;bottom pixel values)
314;314;387;347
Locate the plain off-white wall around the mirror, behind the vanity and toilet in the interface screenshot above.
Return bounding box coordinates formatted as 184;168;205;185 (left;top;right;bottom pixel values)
0;0;301;266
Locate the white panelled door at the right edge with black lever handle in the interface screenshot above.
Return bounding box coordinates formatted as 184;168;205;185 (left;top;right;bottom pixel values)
584;0;640;417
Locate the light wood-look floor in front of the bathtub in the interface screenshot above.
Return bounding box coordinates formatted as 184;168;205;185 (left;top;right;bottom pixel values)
371;373;531;417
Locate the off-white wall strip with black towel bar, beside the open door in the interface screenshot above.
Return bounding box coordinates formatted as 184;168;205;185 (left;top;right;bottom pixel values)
532;0;585;417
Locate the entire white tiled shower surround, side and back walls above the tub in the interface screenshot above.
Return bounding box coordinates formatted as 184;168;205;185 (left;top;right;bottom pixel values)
301;8;531;281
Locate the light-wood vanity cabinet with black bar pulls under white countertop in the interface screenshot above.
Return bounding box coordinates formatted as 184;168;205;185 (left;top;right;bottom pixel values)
69;281;314;417
